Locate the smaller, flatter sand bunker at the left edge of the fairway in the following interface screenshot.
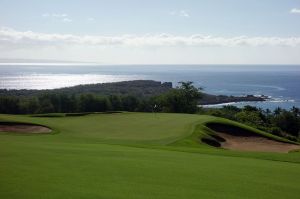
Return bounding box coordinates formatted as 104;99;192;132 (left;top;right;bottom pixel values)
0;122;51;133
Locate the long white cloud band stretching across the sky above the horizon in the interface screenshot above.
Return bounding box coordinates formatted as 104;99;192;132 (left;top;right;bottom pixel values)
0;28;300;47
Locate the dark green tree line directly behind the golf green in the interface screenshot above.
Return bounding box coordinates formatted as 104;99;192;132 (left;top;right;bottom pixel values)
0;82;201;114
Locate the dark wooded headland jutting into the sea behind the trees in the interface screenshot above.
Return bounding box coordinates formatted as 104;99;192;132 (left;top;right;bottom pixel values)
0;80;269;105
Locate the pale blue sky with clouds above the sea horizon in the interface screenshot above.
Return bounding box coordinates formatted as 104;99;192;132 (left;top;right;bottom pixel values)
0;0;300;64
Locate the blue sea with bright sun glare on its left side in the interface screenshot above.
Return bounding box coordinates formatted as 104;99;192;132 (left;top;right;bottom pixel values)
0;65;300;109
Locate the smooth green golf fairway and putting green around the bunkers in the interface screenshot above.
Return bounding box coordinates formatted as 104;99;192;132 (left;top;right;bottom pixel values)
0;113;300;198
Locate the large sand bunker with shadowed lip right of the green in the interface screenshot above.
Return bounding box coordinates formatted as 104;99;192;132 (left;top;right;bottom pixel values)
204;123;300;153
